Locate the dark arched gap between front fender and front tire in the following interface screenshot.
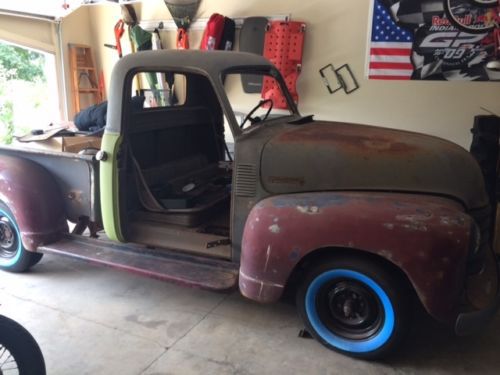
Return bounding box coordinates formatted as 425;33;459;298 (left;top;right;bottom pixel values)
284;247;418;300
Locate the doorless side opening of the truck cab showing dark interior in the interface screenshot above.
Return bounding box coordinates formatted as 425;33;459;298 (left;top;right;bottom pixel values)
122;72;232;257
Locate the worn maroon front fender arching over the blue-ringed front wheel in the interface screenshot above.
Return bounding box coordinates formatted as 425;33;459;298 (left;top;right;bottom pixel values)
240;192;472;321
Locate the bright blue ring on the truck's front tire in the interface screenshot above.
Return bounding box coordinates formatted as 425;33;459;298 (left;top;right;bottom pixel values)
305;269;395;353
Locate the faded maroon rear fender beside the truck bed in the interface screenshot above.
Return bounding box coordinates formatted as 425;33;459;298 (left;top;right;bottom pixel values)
0;156;68;251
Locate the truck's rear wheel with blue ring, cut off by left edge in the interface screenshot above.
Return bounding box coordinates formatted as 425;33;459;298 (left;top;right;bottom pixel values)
0;202;43;272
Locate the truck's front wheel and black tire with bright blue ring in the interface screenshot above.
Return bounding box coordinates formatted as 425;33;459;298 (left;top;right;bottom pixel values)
297;257;411;359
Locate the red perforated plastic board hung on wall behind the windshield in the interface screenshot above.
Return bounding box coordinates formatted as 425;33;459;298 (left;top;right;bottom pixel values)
262;21;306;109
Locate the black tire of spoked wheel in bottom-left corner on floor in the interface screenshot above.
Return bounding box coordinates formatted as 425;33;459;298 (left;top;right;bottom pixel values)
0;316;46;375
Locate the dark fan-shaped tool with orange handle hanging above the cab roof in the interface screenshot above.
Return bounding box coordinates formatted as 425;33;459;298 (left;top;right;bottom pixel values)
164;0;201;49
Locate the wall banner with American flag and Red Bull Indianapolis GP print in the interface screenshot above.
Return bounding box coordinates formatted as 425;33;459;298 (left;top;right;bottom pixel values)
366;0;500;81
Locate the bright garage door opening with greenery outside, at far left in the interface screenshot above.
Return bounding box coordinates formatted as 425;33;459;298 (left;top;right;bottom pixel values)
0;40;61;144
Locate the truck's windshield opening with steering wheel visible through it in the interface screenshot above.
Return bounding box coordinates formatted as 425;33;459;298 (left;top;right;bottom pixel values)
224;73;293;130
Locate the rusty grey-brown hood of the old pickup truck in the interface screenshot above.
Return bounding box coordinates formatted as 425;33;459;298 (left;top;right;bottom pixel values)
261;121;488;209
